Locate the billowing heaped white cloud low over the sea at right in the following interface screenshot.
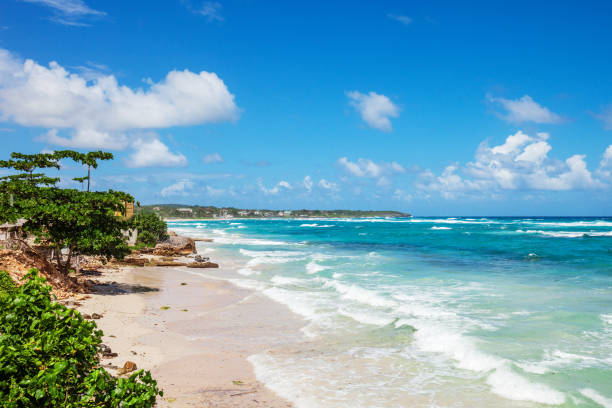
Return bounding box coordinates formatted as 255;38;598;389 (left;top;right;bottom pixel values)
417;131;607;198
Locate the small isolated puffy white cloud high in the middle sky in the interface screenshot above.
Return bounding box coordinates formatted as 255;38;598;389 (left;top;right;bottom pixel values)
347;91;399;132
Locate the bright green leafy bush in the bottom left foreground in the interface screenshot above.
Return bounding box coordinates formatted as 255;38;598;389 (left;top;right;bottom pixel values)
0;270;162;408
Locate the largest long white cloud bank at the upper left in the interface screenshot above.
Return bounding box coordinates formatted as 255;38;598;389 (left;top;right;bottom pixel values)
0;49;238;149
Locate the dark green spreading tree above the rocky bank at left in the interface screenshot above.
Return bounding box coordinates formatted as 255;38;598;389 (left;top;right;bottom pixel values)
0;150;133;272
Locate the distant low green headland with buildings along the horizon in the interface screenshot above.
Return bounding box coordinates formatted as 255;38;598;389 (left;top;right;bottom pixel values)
140;204;410;218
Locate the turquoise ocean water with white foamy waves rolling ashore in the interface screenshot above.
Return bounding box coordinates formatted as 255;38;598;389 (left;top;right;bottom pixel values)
169;217;612;408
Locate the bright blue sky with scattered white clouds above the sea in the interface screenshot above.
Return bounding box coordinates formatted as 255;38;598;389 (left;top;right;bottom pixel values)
0;0;612;216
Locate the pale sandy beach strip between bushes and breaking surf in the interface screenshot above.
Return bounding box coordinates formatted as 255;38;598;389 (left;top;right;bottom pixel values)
79;267;303;407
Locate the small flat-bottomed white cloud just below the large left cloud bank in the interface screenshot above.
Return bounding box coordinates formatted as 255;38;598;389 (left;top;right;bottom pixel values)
126;136;187;167
